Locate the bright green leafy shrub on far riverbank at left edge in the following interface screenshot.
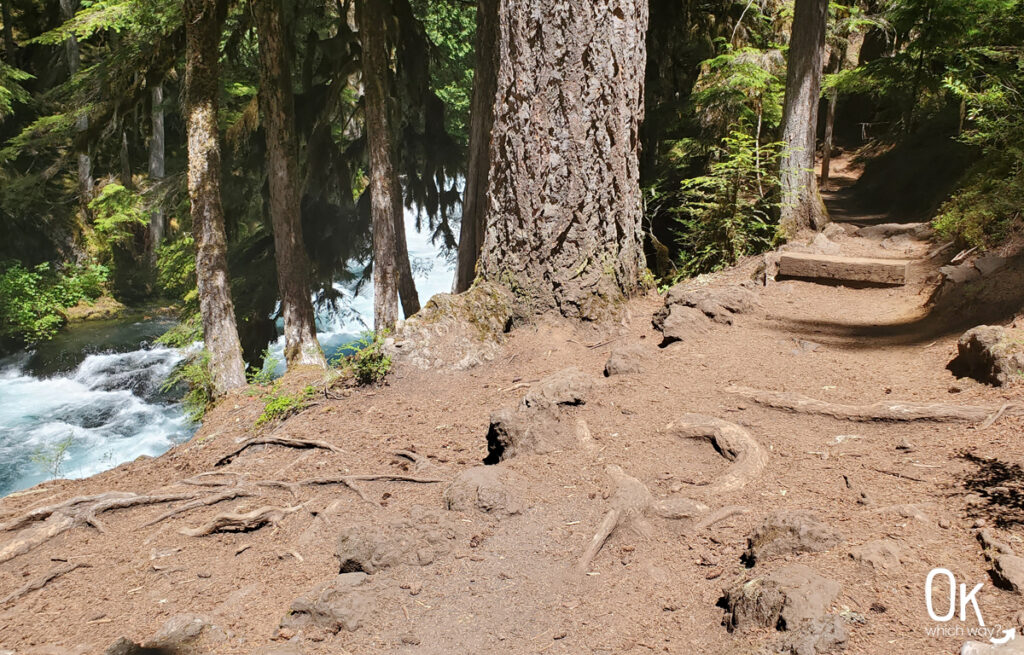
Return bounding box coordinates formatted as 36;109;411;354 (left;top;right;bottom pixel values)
0;262;108;347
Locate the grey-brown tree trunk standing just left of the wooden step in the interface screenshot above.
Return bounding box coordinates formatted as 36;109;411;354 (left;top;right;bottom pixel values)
780;0;828;235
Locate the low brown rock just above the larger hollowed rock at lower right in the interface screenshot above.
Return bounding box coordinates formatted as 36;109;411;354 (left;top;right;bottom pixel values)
743;511;844;565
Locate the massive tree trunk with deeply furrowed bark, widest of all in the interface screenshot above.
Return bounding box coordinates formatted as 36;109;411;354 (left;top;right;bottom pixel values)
479;0;647;318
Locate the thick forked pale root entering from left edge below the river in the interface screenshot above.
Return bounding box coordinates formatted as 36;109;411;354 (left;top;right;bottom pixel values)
0;491;196;564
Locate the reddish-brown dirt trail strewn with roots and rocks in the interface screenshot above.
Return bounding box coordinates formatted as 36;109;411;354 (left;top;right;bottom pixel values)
0;164;1024;655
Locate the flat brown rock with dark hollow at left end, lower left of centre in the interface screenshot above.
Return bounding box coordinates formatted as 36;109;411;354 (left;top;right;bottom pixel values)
336;507;455;574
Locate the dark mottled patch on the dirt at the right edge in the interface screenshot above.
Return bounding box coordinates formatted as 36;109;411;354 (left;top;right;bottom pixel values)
959;451;1024;528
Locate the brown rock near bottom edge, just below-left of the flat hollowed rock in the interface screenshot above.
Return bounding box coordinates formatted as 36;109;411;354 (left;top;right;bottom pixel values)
281;572;373;632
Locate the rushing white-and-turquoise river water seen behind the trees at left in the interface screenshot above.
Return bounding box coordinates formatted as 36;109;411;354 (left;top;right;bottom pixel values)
0;213;455;496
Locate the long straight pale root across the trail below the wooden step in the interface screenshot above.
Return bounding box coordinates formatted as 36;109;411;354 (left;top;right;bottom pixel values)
725;387;1021;427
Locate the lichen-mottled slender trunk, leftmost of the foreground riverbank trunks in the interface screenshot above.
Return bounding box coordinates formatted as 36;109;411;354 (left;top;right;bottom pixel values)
184;0;246;394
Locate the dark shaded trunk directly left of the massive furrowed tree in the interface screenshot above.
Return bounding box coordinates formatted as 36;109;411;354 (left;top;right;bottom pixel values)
454;0;498;294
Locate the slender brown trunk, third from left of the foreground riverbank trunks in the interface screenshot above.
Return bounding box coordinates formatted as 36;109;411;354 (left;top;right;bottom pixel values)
359;0;398;330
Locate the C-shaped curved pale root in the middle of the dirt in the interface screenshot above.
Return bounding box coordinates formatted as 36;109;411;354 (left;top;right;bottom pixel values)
670;413;768;497
